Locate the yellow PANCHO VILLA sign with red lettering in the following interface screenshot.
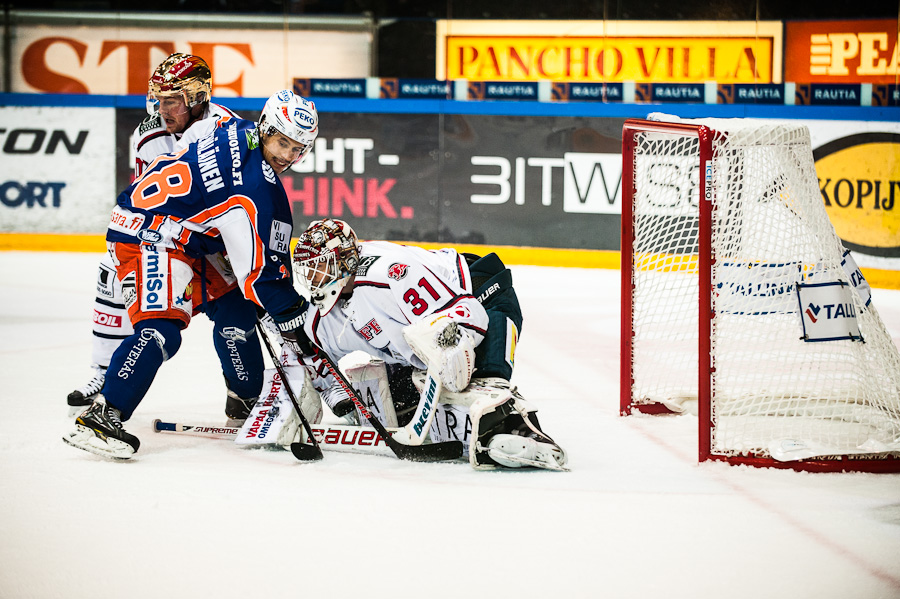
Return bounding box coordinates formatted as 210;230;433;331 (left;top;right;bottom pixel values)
436;20;782;83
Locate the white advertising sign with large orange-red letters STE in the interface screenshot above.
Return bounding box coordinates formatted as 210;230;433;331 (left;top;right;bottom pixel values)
10;15;373;97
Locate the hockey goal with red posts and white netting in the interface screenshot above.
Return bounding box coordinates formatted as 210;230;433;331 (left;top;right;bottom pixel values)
620;119;900;472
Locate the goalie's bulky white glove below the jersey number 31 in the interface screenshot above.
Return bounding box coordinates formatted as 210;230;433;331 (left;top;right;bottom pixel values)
403;314;475;393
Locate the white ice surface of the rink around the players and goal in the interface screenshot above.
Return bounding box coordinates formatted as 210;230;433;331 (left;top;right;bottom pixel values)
0;252;900;599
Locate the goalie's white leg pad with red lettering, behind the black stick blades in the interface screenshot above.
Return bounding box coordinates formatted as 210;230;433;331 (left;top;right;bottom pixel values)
234;366;322;446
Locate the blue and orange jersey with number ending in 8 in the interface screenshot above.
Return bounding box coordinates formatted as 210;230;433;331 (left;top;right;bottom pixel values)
106;118;300;322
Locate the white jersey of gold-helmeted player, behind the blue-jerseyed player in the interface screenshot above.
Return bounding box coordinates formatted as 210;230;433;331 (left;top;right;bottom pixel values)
131;102;238;179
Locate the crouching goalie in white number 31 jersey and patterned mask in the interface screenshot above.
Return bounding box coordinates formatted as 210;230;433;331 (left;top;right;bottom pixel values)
284;219;567;470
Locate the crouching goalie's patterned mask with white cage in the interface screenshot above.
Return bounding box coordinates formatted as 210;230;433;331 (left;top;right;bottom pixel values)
293;219;359;316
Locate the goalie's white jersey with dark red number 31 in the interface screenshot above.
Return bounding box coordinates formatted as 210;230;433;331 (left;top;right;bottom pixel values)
305;241;488;389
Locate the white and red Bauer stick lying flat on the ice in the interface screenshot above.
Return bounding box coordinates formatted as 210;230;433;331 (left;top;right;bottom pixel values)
153;419;398;457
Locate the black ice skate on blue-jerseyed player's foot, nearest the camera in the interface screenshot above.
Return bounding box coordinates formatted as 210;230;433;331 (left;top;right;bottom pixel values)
63;395;141;460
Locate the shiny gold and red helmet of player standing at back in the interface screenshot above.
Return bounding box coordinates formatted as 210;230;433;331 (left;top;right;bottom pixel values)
147;54;212;114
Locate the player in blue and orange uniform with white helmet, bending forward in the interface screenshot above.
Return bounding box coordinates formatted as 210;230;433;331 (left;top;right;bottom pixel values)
63;90;318;459
